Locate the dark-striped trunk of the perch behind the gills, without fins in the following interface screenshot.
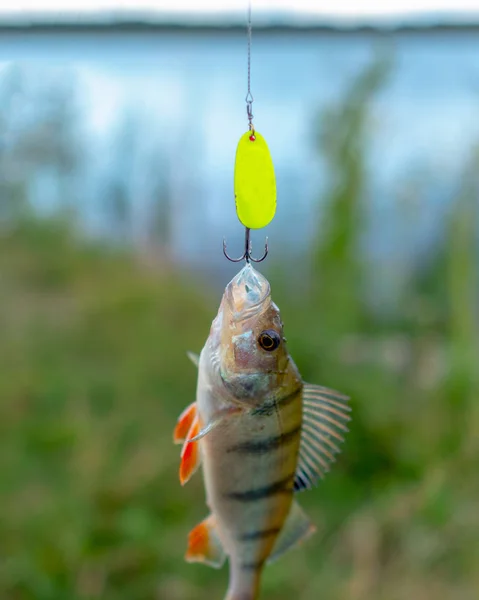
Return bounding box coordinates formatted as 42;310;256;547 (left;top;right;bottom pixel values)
198;368;302;600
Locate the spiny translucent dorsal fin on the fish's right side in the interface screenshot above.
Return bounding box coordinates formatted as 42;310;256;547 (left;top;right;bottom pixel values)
294;384;351;492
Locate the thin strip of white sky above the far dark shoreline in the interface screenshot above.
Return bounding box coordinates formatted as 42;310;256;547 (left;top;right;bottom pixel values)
0;0;479;20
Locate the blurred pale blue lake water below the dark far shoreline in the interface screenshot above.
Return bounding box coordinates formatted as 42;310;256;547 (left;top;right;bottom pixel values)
0;29;479;270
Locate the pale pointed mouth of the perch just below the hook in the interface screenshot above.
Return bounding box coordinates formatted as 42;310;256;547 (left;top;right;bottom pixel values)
225;263;271;321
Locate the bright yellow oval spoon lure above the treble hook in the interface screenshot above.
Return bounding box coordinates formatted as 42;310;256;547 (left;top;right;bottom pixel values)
234;130;276;229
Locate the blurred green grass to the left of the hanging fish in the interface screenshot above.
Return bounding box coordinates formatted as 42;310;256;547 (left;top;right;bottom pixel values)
0;221;218;599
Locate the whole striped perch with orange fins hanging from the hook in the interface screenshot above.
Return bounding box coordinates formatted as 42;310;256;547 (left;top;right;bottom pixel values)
173;263;350;600
